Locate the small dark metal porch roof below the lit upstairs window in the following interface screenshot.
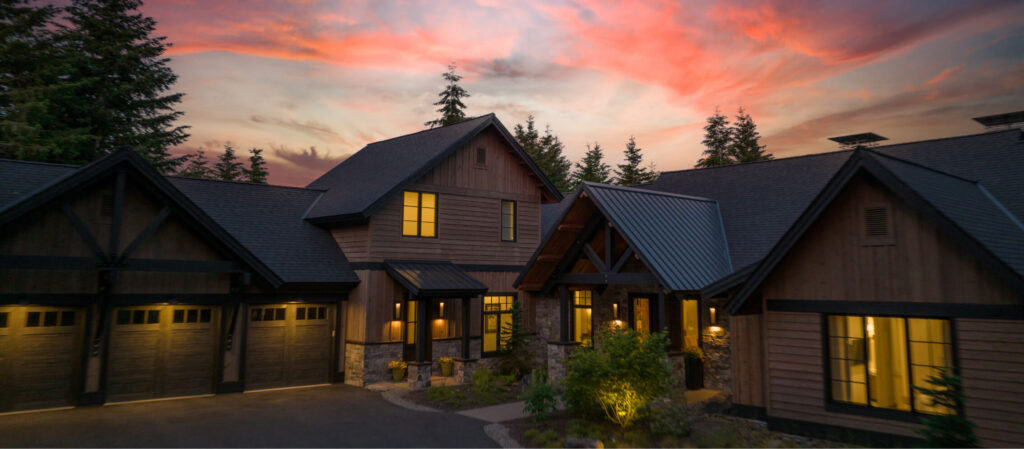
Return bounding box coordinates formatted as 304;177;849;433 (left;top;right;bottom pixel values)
384;260;487;296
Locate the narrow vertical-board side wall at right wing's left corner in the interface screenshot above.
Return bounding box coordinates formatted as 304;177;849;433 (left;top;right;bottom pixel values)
728;315;765;407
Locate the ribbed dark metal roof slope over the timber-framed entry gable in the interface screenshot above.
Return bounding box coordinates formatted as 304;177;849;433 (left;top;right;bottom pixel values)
583;182;732;291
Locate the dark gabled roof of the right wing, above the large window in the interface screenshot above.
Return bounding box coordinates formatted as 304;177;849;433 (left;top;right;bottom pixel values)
727;149;1024;314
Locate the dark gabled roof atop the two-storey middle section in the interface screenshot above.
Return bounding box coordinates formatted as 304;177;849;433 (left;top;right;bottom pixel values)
306;114;561;223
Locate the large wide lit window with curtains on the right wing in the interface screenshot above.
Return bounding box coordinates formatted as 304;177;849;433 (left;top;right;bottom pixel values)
827;316;952;413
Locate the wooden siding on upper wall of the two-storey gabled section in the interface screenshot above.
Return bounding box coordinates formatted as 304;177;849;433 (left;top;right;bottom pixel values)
352;128;541;266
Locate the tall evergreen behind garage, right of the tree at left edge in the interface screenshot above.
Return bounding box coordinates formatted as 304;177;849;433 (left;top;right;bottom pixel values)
58;0;188;173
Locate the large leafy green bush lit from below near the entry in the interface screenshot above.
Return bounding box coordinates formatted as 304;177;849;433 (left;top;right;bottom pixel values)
562;328;672;428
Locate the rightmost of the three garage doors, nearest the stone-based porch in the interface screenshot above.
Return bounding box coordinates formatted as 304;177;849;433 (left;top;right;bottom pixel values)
246;304;334;390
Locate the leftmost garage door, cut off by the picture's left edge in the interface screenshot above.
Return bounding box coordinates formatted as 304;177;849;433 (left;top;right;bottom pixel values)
0;307;85;411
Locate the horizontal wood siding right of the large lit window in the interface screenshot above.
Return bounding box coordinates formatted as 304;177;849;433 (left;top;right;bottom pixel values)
955;319;1024;447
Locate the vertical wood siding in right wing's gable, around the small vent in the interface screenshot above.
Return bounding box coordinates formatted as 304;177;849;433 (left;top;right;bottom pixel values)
762;176;1021;304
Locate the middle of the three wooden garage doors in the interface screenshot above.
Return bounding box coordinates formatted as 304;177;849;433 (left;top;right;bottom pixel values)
106;305;218;402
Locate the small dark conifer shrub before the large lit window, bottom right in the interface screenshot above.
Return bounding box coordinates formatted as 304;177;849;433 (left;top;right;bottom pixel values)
913;370;978;447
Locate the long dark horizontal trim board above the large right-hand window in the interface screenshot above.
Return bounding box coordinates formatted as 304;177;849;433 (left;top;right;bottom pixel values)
767;299;1024;320
